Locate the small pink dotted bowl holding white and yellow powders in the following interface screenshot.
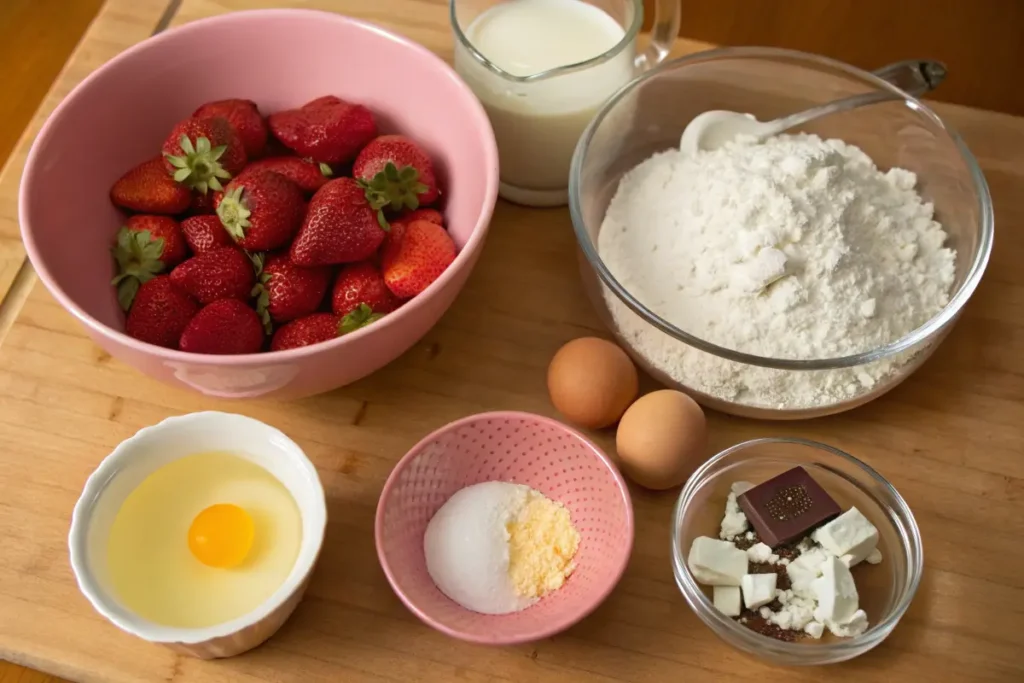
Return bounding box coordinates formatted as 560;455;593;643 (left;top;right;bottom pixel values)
375;412;633;645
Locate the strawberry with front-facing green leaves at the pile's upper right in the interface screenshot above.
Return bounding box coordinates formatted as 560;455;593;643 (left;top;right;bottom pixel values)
352;135;438;211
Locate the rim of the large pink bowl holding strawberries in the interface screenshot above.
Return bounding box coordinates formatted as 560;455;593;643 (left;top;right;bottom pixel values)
18;8;499;368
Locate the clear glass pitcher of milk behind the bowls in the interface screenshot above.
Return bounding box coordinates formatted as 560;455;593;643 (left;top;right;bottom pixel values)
451;0;681;206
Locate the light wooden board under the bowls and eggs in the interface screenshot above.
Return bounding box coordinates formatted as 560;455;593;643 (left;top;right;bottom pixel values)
0;0;1024;683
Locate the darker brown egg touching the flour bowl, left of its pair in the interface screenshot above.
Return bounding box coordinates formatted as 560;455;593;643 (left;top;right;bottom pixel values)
548;337;639;429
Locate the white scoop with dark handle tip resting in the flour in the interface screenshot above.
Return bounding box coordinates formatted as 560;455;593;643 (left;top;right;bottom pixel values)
679;60;946;155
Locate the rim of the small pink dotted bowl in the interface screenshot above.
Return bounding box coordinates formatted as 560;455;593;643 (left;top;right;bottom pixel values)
374;411;636;645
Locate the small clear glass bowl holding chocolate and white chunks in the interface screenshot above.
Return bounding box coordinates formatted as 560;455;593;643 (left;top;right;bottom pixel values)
672;438;924;666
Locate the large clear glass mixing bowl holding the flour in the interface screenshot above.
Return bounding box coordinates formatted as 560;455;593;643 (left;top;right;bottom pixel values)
569;48;993;419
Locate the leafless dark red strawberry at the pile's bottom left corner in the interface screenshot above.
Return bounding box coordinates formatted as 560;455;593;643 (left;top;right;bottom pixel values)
125;275;199;348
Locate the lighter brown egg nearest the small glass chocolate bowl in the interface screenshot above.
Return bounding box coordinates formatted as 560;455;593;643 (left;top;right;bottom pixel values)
615;389;708;490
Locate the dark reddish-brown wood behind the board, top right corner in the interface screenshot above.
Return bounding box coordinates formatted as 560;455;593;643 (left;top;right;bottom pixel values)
644;0;1024;116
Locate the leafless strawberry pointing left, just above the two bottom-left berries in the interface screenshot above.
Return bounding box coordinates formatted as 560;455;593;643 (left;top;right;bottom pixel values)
171;247;256;304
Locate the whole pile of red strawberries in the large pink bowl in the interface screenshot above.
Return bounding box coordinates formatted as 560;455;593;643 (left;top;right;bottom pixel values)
111;95;456;353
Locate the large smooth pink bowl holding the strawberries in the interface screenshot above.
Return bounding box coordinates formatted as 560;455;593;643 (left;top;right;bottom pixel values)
19;9;498;398
